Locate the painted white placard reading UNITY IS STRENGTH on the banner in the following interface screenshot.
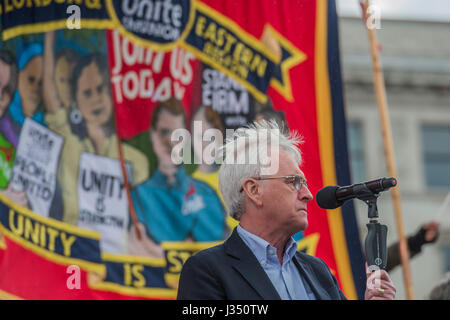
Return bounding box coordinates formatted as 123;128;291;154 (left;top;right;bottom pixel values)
78;153;132;254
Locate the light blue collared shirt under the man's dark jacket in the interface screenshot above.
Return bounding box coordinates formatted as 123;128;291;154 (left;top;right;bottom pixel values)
236;224;315;300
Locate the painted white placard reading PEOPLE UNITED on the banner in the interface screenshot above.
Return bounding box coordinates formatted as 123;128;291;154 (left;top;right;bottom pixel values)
11;118;63;217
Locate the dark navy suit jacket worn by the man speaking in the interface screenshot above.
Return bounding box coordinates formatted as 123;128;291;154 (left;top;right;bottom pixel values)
177;230;346;300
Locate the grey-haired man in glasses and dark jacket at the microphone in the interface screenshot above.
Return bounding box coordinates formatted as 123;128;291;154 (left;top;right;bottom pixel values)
178;121;395;300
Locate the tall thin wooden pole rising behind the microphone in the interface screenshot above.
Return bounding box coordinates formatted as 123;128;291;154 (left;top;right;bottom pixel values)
360;0;414;300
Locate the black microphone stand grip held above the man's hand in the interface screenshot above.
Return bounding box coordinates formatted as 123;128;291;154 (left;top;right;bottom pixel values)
354;184;387;272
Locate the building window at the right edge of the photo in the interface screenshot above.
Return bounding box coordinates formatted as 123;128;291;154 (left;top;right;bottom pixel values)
422;125;450;187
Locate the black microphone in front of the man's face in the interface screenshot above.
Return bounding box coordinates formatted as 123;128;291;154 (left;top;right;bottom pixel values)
316;178;397;209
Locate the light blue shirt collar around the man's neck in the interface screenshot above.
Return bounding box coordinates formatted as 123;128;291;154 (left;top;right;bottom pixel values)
236;224;297;265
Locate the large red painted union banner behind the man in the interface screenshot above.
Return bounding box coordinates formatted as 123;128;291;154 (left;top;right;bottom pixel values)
0;0;365;299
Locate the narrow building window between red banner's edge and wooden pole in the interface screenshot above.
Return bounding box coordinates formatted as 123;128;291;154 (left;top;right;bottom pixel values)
347;121;366;183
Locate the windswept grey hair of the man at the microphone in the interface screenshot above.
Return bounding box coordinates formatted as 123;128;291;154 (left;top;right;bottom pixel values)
219;120;303;221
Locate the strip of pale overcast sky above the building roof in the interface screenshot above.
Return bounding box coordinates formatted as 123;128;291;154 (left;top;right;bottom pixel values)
336;0;450;22
